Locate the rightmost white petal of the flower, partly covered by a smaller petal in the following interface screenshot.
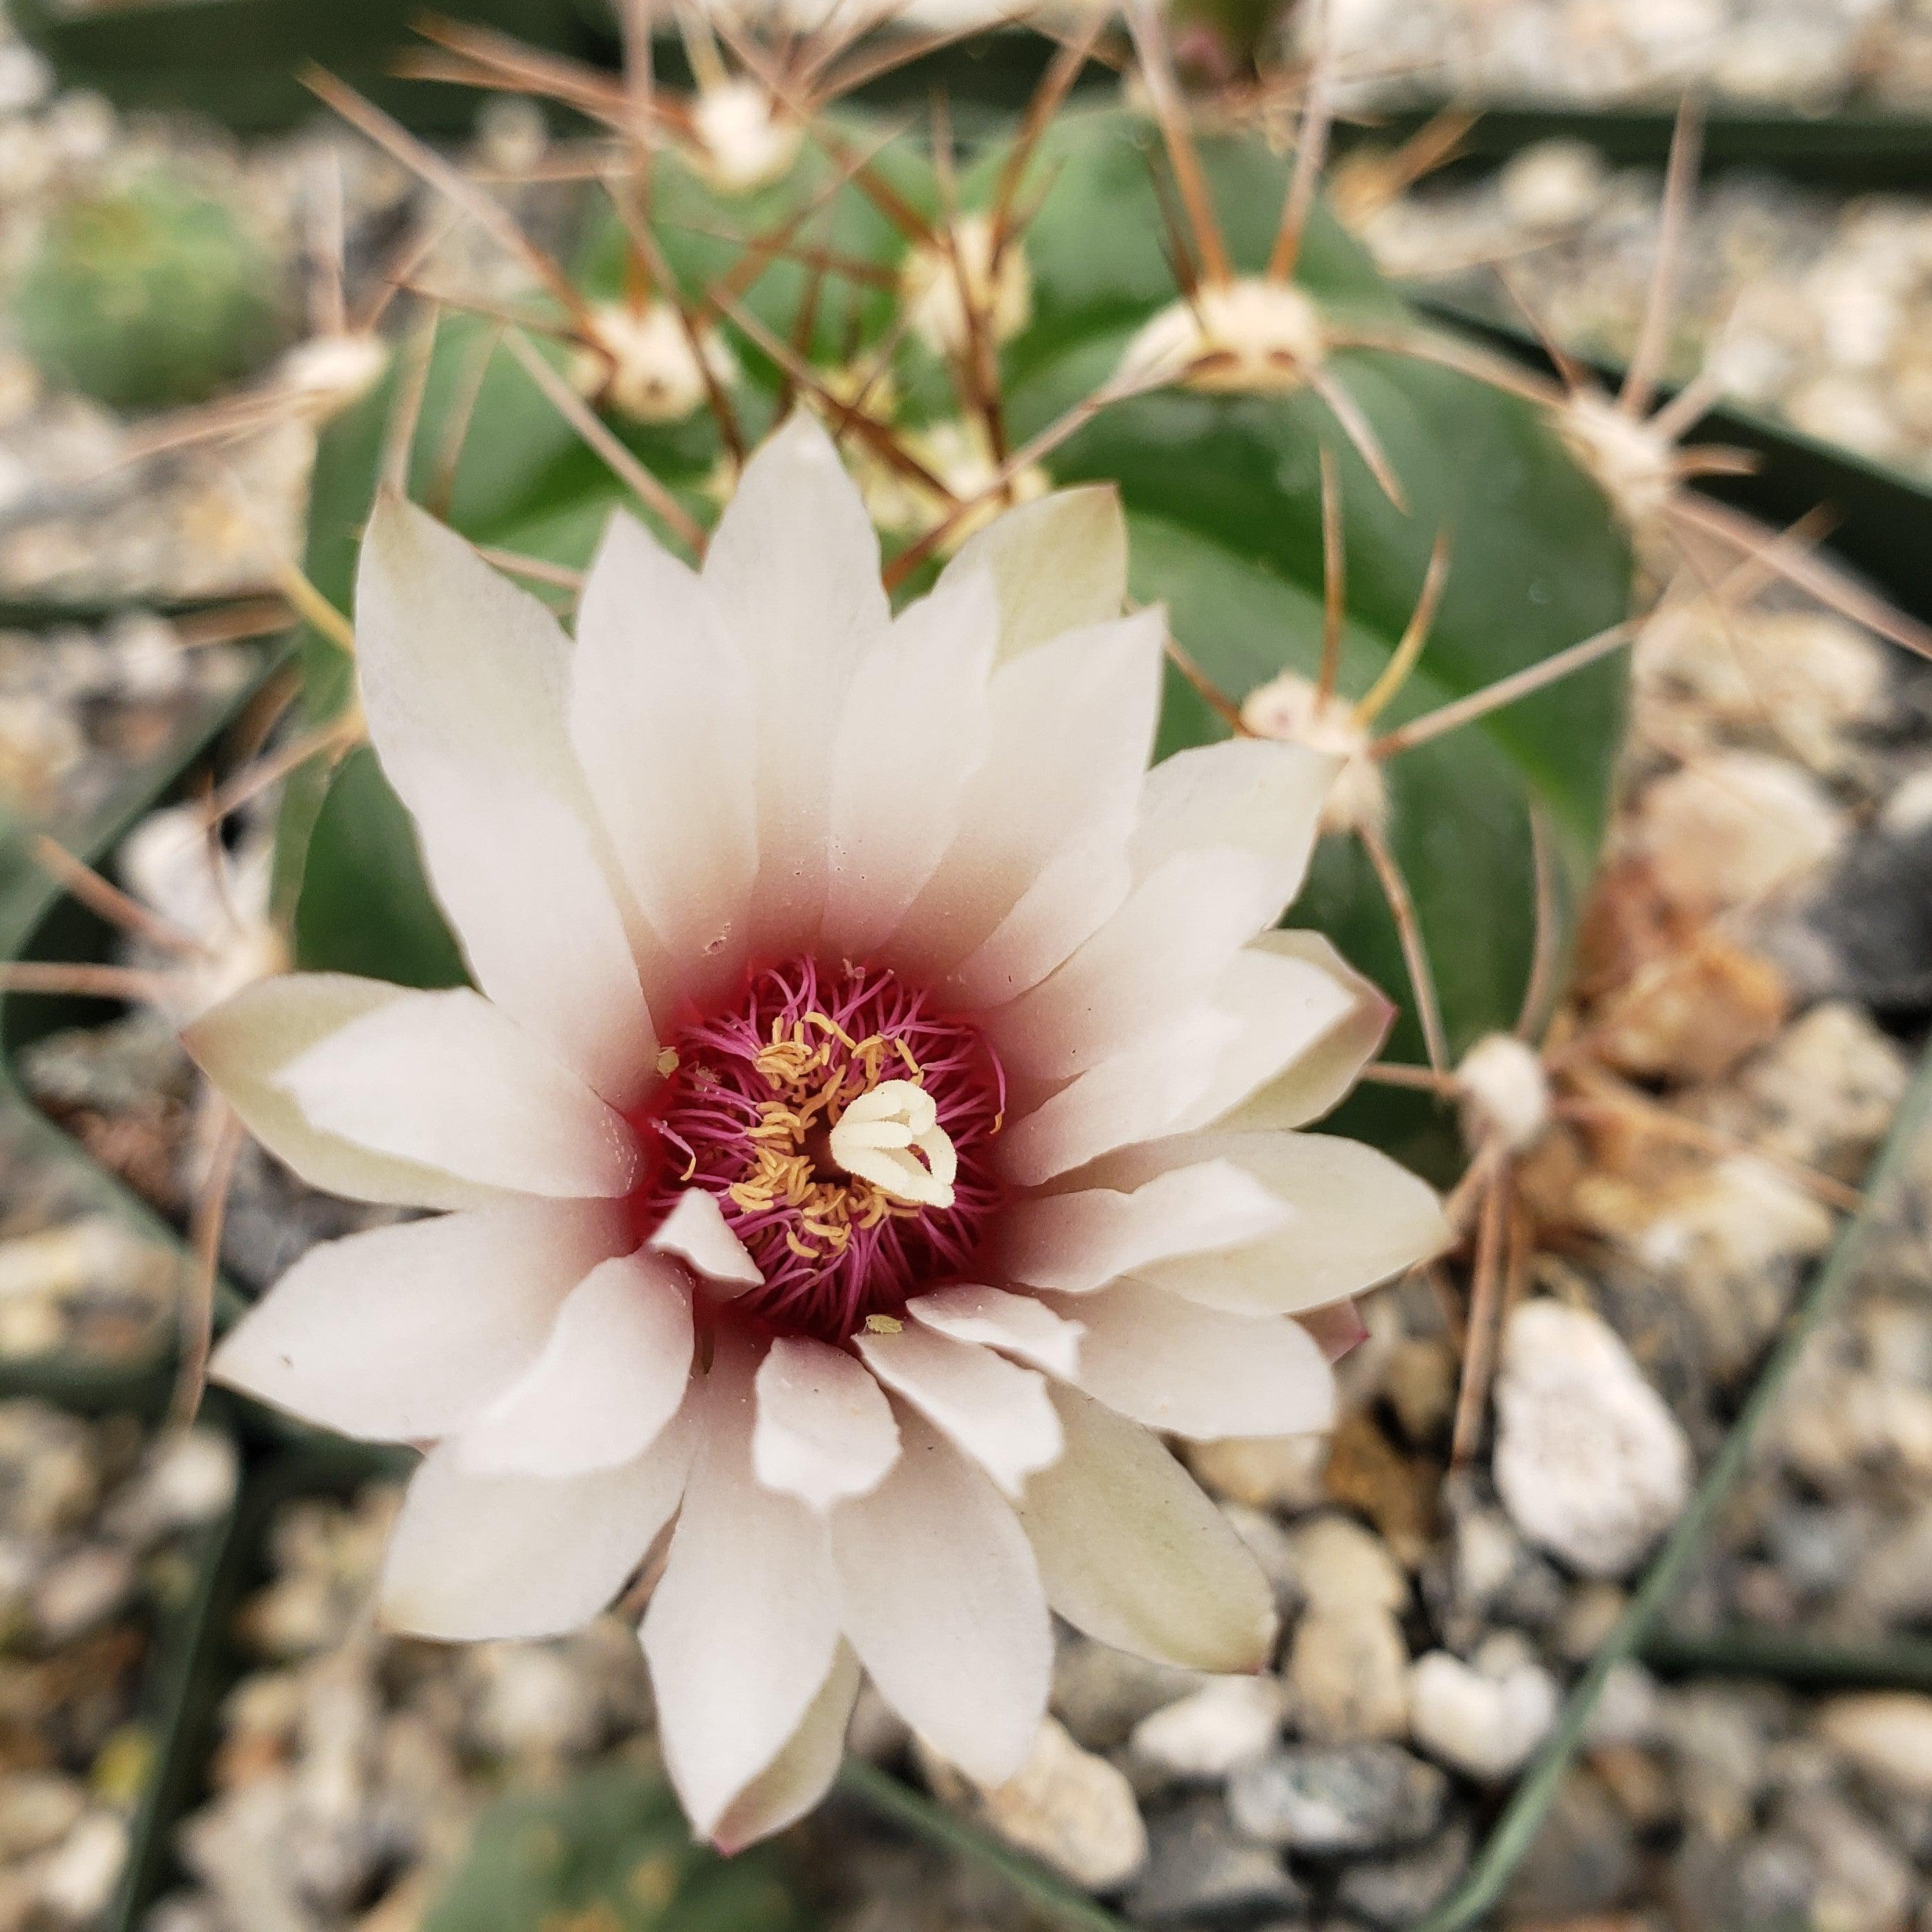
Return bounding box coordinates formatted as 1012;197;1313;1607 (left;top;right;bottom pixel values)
1136;1132;1449;1314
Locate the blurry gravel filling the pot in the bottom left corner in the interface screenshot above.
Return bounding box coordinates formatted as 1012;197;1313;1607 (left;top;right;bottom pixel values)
0;1401;236;1932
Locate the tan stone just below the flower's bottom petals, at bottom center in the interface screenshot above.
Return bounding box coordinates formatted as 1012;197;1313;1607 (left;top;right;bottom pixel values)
919;1718;1148;1891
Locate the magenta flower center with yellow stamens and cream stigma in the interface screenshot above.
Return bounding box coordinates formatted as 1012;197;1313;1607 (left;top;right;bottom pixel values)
632;958;1004;1341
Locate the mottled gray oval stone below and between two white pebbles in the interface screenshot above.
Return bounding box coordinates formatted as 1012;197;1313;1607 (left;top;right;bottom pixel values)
1229;1745;1449;1859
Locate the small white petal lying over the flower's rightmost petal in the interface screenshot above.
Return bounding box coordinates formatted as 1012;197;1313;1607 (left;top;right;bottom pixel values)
999;1161;1293;1294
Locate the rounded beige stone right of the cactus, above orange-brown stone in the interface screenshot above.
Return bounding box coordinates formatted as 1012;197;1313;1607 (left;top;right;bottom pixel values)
1638;751;1849;916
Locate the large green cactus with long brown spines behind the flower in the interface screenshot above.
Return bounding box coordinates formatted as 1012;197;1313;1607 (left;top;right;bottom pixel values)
272;48;1630;1171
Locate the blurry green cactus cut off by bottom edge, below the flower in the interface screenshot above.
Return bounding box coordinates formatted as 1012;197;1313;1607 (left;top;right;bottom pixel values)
423;1764;809;1932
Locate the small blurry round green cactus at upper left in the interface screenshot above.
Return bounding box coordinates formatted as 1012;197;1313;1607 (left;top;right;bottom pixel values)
14;168;282;410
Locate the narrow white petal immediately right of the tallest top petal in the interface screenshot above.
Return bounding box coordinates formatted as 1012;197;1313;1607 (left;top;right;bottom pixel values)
825;572;999;957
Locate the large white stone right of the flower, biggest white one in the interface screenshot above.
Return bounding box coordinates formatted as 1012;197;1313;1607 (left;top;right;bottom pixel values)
1496;1300;1691;1576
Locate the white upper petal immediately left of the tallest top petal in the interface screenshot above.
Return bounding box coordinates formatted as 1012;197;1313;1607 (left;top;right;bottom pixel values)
570;512;757;995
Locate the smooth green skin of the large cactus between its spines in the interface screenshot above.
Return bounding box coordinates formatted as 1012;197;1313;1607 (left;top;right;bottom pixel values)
286;112;1630;1171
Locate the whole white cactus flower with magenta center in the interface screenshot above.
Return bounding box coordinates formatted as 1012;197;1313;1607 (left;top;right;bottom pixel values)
187;415;1443;1847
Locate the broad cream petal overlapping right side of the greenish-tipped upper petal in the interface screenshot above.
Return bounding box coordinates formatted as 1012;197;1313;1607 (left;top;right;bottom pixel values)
894;609;1167;974
